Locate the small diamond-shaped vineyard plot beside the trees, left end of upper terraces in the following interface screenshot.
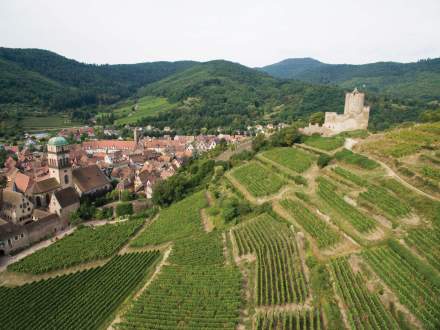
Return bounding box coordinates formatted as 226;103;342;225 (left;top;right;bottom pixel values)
232;163;285;197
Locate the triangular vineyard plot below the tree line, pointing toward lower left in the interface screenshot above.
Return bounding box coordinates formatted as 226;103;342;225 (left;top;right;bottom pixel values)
130;191;206;247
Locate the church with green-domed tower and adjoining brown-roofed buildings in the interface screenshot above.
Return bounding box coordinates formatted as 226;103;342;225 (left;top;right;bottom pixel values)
0;136;112;256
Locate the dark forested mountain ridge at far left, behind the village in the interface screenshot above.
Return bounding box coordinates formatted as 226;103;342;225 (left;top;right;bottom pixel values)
0;48;195;110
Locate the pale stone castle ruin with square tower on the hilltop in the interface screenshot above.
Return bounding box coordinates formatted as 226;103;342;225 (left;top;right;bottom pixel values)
300;88;370;136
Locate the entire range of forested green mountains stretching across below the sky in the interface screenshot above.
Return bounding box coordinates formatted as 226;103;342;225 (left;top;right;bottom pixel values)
0;48;440;140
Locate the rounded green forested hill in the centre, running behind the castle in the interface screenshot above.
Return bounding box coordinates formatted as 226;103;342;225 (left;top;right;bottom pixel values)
139;61;426;133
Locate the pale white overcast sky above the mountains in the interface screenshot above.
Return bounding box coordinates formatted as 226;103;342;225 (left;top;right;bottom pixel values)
0;0;440;66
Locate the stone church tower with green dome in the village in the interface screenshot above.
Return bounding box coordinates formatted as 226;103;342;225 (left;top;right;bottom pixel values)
47;136;72;188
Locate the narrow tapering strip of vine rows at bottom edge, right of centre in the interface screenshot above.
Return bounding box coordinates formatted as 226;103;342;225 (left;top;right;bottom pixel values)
330;258;399;329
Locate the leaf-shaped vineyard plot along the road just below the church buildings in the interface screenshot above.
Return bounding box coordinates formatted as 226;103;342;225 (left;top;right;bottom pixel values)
8;219;144;274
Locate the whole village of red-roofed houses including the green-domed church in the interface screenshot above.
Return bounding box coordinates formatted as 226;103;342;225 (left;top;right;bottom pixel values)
0;127;251;255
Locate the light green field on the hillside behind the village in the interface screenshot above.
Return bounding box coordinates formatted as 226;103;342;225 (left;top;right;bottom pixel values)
113;96;176;125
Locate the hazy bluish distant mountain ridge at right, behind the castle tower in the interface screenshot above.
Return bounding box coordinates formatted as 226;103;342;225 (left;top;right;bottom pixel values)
260;58;440;100
